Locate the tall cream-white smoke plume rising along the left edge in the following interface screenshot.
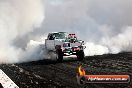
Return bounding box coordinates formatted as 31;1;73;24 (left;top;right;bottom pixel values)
0;0;44;63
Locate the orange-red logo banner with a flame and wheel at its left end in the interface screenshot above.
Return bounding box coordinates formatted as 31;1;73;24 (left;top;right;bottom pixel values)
77;66;130;84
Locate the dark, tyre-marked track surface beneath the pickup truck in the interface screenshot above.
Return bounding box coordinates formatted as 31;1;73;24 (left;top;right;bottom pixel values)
0;53;132;88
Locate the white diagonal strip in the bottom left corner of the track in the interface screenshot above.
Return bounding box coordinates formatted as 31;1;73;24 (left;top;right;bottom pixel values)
0;69;19;88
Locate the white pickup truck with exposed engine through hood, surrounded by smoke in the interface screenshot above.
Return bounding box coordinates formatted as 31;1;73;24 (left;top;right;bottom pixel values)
45;32;85;61
